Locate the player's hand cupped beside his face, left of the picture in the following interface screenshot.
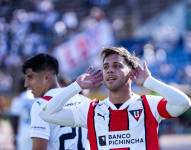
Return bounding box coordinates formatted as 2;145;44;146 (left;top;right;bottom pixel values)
76;67;103;89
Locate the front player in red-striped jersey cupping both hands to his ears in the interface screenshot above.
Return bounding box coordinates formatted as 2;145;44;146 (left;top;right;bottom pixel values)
40;47;191;150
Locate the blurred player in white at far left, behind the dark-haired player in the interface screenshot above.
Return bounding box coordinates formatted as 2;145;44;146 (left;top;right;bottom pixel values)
10;82;35;150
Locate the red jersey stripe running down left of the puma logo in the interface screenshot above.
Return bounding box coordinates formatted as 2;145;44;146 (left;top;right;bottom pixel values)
87;101;98;150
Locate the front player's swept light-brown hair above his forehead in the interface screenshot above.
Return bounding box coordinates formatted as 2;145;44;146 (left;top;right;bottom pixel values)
101;47;139;69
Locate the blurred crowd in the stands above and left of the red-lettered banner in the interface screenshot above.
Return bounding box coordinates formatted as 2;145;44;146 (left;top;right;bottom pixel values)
0;0;116;92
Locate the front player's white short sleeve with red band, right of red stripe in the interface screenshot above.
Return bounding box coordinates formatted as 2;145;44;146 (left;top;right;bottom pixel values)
146;95;172;122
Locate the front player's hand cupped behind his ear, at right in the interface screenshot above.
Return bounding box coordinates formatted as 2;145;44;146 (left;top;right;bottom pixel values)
130;62;151;86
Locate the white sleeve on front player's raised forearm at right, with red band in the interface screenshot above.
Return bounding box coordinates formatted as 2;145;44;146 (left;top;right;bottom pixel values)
144;76;191;118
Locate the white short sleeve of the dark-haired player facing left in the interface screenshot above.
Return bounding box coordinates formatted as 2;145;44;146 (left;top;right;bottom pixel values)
30;99;50;140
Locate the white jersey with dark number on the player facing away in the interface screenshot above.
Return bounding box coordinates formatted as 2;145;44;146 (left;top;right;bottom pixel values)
31;89;87;150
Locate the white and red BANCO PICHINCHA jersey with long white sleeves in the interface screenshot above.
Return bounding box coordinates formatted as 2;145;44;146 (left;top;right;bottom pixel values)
40;77;191;150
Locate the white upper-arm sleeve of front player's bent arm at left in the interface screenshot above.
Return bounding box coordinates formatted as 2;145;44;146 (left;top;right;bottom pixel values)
40;94;90;127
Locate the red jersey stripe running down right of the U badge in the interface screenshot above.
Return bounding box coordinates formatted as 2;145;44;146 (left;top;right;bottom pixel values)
142;95;159;150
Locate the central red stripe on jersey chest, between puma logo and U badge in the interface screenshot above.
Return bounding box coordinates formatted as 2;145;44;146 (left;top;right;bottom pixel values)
109;108;129;150
